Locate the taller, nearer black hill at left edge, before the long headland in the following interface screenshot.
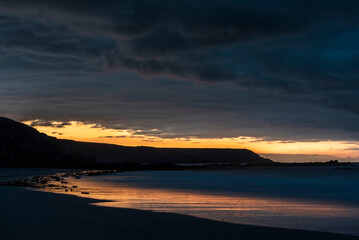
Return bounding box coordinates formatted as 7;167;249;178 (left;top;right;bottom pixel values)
0;117;95;167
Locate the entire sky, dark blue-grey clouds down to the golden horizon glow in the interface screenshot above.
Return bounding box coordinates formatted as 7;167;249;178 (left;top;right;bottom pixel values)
0;0;359;161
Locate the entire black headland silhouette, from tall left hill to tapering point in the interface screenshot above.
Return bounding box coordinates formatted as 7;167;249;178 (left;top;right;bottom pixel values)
0;117;272;167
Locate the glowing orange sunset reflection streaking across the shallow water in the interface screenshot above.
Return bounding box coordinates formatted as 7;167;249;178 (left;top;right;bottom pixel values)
44;176;358;217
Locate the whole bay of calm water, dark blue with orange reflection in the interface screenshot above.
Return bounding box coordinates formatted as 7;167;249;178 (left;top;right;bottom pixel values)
40;168;359;236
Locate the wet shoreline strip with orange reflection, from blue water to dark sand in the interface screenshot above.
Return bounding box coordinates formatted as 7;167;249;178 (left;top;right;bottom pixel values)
38;172;359;235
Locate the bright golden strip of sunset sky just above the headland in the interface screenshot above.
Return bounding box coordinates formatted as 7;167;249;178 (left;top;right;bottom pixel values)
24;121;359;158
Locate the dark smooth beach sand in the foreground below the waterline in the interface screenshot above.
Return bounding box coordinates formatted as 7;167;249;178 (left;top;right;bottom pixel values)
0;187;359;240
